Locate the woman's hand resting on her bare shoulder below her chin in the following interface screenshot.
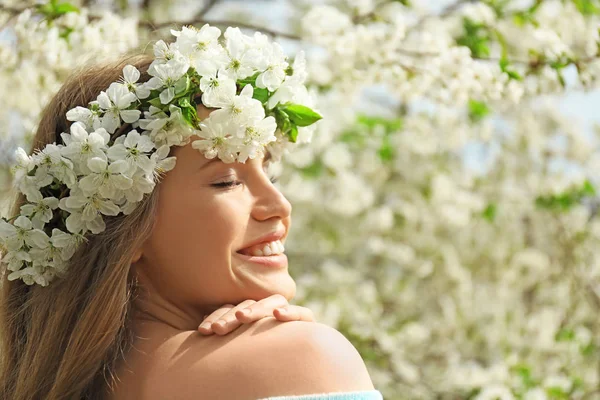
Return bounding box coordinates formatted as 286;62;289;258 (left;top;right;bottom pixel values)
198;294;315;336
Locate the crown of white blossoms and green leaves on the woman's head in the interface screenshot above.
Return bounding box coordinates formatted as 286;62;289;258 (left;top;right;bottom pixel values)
0;24;321;286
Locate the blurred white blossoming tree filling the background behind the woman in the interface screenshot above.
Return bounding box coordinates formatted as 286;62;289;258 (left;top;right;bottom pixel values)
0;0;600;400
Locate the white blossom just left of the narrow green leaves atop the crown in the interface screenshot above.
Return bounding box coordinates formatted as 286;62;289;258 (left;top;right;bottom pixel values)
146;59;189;104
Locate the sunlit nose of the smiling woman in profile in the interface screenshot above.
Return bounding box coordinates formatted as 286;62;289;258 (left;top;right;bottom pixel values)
252;173;292;221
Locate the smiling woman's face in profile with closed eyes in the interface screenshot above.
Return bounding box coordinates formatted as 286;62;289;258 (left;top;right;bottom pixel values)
133;113;296;328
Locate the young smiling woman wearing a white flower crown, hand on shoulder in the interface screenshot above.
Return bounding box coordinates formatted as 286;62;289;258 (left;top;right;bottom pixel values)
0;26;381;400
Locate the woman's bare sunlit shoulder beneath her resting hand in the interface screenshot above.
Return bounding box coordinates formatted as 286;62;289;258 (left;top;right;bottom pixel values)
149;318;373;400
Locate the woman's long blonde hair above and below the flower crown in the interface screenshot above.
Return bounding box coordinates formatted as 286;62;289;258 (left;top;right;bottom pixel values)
0;55;158;400
